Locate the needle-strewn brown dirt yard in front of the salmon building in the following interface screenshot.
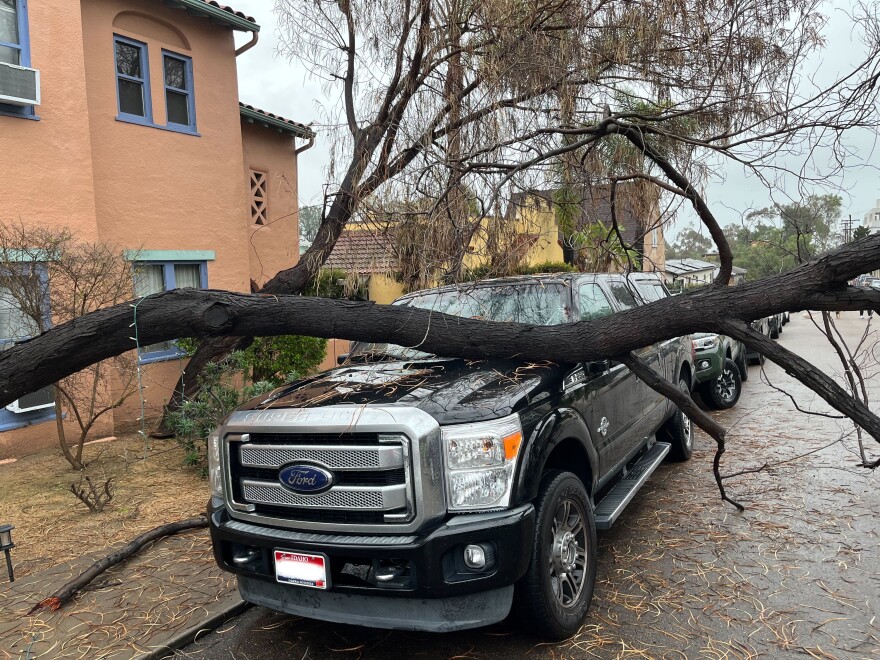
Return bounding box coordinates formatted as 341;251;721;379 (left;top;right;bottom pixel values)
0;434;208;578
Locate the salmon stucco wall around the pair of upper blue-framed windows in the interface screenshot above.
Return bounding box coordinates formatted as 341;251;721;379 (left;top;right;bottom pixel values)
82;0;249;291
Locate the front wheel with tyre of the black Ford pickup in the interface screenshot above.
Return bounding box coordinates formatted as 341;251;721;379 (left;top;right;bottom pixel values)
514;470;596;640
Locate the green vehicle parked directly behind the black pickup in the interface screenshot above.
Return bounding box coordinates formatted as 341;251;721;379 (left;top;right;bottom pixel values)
691;332;749;410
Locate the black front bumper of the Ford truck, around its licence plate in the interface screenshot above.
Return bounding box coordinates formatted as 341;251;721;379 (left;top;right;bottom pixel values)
208;500;535;631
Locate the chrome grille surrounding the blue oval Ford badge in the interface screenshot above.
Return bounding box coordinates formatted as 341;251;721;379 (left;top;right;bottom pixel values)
221;405;446;534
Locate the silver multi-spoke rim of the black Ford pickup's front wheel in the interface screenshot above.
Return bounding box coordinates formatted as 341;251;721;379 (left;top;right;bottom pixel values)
550;498;587;608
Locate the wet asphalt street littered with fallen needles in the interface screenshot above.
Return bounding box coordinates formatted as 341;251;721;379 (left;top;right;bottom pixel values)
178;312;880;660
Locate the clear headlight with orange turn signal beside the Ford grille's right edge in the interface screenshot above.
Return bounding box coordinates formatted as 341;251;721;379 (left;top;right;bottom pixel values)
440;414;522;511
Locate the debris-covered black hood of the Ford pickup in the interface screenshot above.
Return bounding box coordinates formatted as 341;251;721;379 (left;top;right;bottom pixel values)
239;358;564;424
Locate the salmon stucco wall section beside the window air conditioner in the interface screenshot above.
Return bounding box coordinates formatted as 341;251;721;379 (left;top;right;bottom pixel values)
0;0;97;240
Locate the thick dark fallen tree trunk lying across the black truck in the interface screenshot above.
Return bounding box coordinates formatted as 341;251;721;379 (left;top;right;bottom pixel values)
0;235;880;448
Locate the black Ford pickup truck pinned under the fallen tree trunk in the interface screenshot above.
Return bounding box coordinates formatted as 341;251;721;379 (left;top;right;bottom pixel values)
209;273;694;639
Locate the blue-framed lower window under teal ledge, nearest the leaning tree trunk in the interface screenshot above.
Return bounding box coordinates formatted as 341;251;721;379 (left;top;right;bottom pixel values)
134;261;208;363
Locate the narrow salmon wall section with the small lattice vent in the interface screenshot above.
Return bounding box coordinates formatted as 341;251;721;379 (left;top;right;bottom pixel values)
241;121;299;285
